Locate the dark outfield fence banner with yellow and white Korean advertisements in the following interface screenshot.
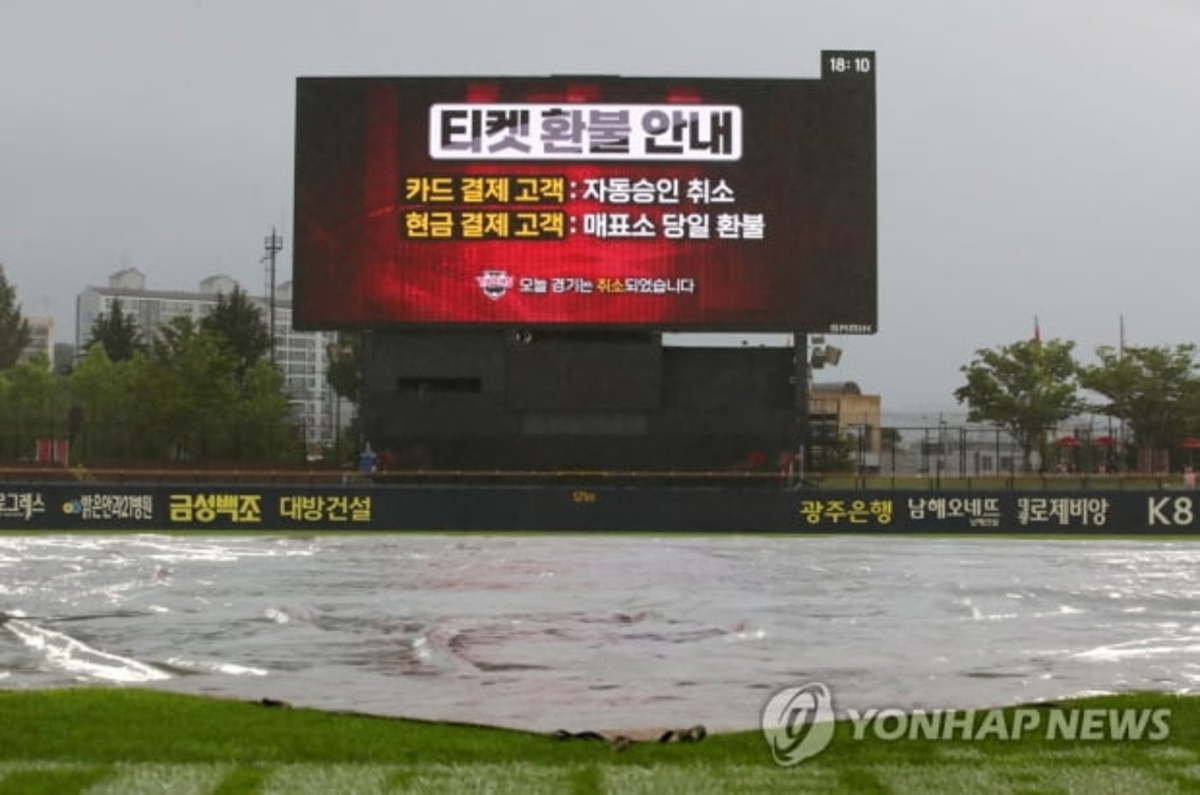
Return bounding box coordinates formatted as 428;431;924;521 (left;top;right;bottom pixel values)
0;483;1200;533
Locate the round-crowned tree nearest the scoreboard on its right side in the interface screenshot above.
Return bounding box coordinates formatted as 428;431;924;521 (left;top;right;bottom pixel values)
954;340;1086;471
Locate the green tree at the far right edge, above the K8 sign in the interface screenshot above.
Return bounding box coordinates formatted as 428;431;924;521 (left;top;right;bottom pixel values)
1079;343;1200;458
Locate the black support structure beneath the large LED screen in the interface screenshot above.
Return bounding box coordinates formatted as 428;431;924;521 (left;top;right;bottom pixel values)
362;330;806;473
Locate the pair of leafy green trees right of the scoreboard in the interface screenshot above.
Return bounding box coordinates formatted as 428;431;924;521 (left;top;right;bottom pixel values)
954;339;1200;470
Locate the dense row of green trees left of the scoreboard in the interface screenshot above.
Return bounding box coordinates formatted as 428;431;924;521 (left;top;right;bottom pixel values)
0;269;304;466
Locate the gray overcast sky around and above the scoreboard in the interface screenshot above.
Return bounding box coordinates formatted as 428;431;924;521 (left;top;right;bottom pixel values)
0;0;1200;411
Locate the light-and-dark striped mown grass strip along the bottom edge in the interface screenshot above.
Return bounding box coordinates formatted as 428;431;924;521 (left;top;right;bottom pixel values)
0;761;1200;795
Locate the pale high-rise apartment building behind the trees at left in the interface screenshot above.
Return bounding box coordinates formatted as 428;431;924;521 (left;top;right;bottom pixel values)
76;268;353;452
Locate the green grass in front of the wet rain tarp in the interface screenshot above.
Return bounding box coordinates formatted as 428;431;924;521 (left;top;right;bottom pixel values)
0;689;1200;795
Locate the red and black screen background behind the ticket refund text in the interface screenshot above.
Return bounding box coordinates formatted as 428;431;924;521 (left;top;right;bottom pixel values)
294;77;876;330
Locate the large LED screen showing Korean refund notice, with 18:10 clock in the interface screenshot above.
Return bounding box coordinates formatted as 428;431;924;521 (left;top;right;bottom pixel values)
294;52;876;334
